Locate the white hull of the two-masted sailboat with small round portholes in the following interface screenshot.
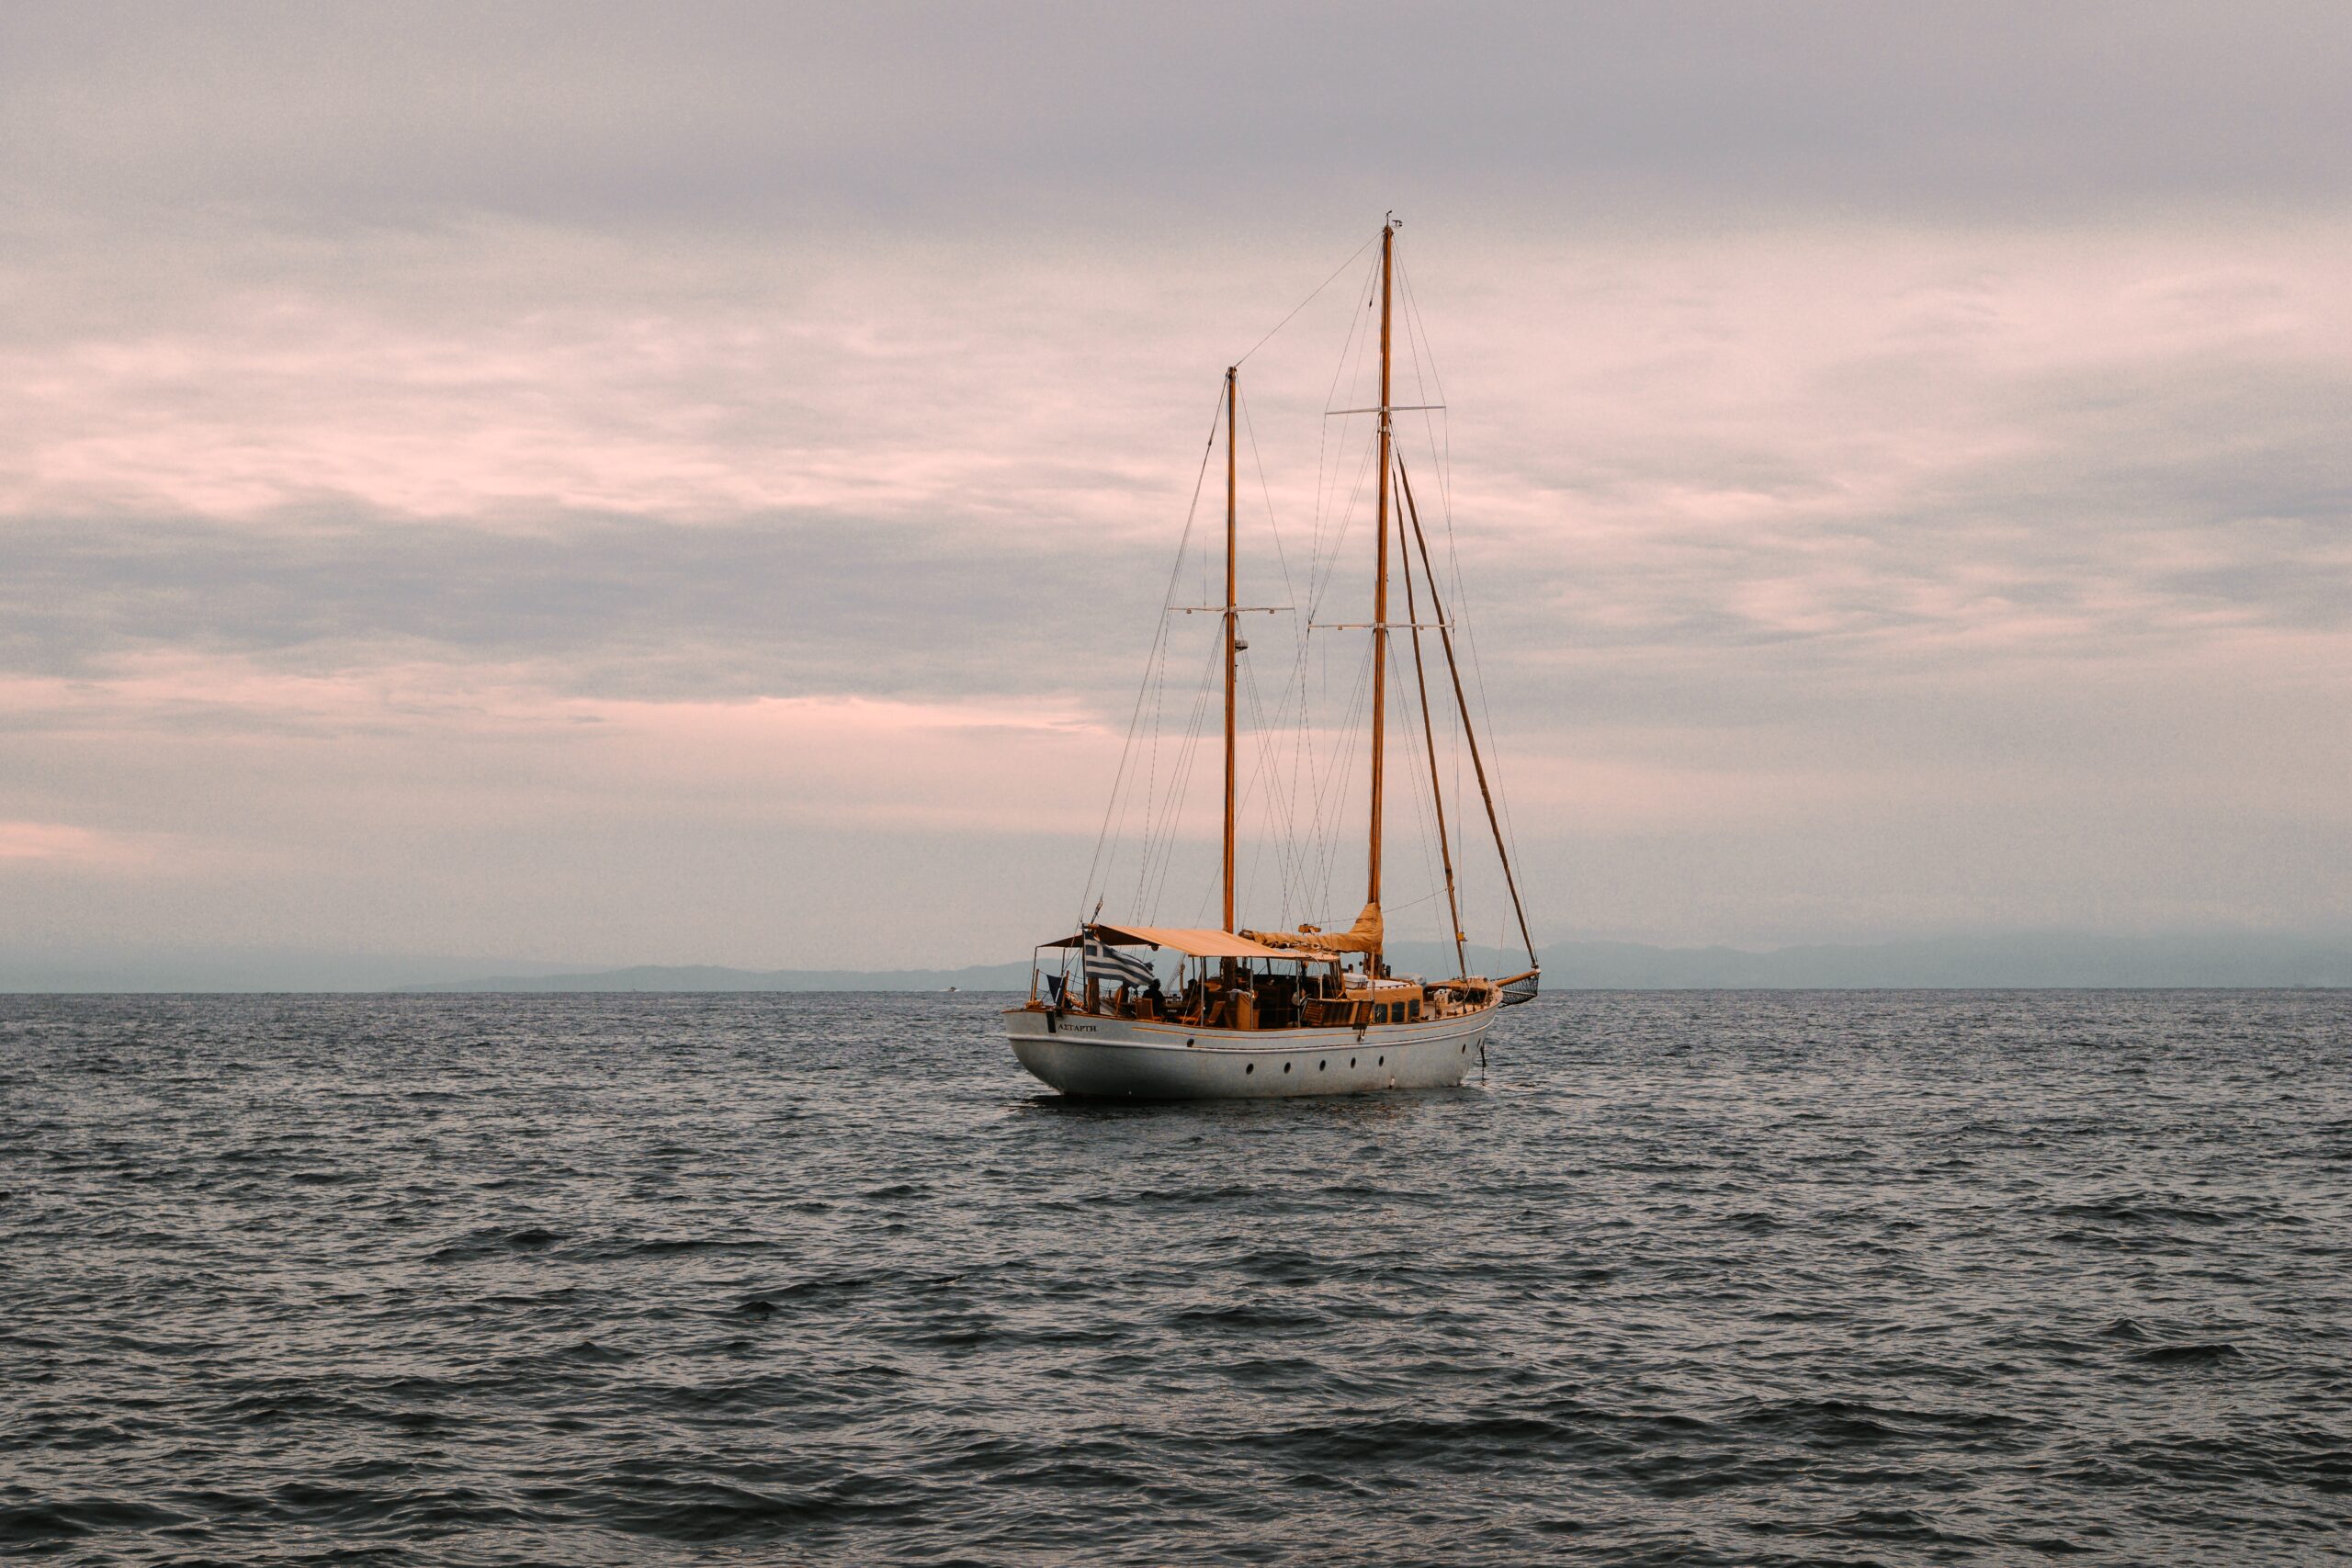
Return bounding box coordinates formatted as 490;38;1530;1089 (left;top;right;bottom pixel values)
1004;1006;1494;1100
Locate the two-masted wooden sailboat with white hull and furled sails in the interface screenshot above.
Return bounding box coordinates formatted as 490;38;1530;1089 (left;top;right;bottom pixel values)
1004;216;1541;1100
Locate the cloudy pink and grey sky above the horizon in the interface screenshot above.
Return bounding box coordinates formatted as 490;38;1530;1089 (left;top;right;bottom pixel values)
0;3;2352;980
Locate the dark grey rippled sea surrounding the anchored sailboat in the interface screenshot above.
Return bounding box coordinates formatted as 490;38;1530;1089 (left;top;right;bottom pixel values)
0;992;2352;1565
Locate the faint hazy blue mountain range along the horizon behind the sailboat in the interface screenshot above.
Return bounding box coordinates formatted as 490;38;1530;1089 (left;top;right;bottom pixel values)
400;933;2352;992
